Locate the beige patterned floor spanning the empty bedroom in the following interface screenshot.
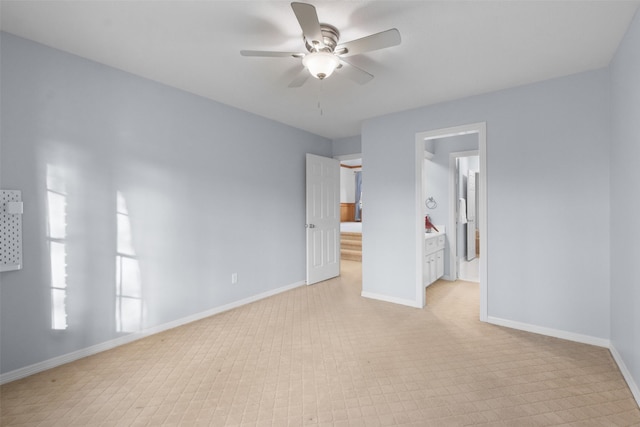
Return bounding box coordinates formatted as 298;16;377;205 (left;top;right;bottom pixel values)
0;261;640;426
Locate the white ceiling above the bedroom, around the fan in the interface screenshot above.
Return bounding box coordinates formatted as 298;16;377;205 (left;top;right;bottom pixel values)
0;0;639;139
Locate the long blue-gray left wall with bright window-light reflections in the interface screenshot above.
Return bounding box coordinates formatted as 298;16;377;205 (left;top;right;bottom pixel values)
0;33;332;373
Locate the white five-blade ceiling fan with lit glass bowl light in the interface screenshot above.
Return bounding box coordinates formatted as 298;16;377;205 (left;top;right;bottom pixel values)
240;2;400;87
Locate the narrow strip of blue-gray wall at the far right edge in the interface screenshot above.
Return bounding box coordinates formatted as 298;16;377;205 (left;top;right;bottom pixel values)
610;13;640;401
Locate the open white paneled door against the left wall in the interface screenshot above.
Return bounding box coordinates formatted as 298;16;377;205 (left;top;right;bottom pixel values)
306;154;340;285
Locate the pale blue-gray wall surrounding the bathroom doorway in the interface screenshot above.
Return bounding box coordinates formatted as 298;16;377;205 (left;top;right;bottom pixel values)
362;69;610;339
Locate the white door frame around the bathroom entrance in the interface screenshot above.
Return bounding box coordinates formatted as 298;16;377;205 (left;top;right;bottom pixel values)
415;122;489;322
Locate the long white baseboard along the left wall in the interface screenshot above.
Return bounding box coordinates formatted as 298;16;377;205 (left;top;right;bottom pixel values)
0;280;305;384
